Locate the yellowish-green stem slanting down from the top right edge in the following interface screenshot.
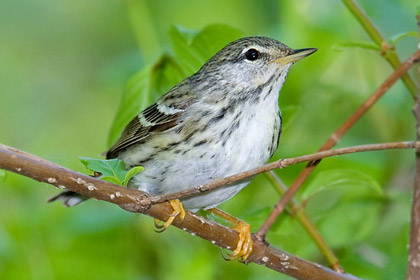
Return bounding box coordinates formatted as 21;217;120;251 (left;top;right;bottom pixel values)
343;0;417;99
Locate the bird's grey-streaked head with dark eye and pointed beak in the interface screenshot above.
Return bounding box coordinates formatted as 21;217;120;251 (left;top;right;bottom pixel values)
197;36;317;98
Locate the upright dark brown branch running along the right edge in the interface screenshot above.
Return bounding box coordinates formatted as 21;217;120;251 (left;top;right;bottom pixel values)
407;15;420;280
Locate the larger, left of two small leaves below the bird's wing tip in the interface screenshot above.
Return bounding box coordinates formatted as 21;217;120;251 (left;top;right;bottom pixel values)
79;157;127;185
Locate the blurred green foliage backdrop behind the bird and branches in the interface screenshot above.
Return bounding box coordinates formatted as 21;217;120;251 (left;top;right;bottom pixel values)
0;0;418;280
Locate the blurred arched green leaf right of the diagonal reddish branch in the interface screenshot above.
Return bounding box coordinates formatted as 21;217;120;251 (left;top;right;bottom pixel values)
301;169;382;210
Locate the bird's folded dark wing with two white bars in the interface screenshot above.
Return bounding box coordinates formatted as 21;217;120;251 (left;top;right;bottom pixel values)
106;86;195;159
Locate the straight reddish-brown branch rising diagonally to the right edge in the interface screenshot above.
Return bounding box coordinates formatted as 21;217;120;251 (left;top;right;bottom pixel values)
257;50;420;240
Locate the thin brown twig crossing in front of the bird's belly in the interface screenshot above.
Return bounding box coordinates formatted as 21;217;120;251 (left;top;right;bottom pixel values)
149;142;420;204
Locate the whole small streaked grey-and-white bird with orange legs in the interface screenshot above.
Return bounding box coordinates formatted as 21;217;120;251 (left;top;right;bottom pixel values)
51;36;317;260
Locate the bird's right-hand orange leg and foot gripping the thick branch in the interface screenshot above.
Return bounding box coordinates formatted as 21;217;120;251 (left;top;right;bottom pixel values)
209;208;253;261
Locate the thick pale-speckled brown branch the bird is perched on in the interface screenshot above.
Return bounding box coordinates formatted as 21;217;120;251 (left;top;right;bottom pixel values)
0;144;358;280
